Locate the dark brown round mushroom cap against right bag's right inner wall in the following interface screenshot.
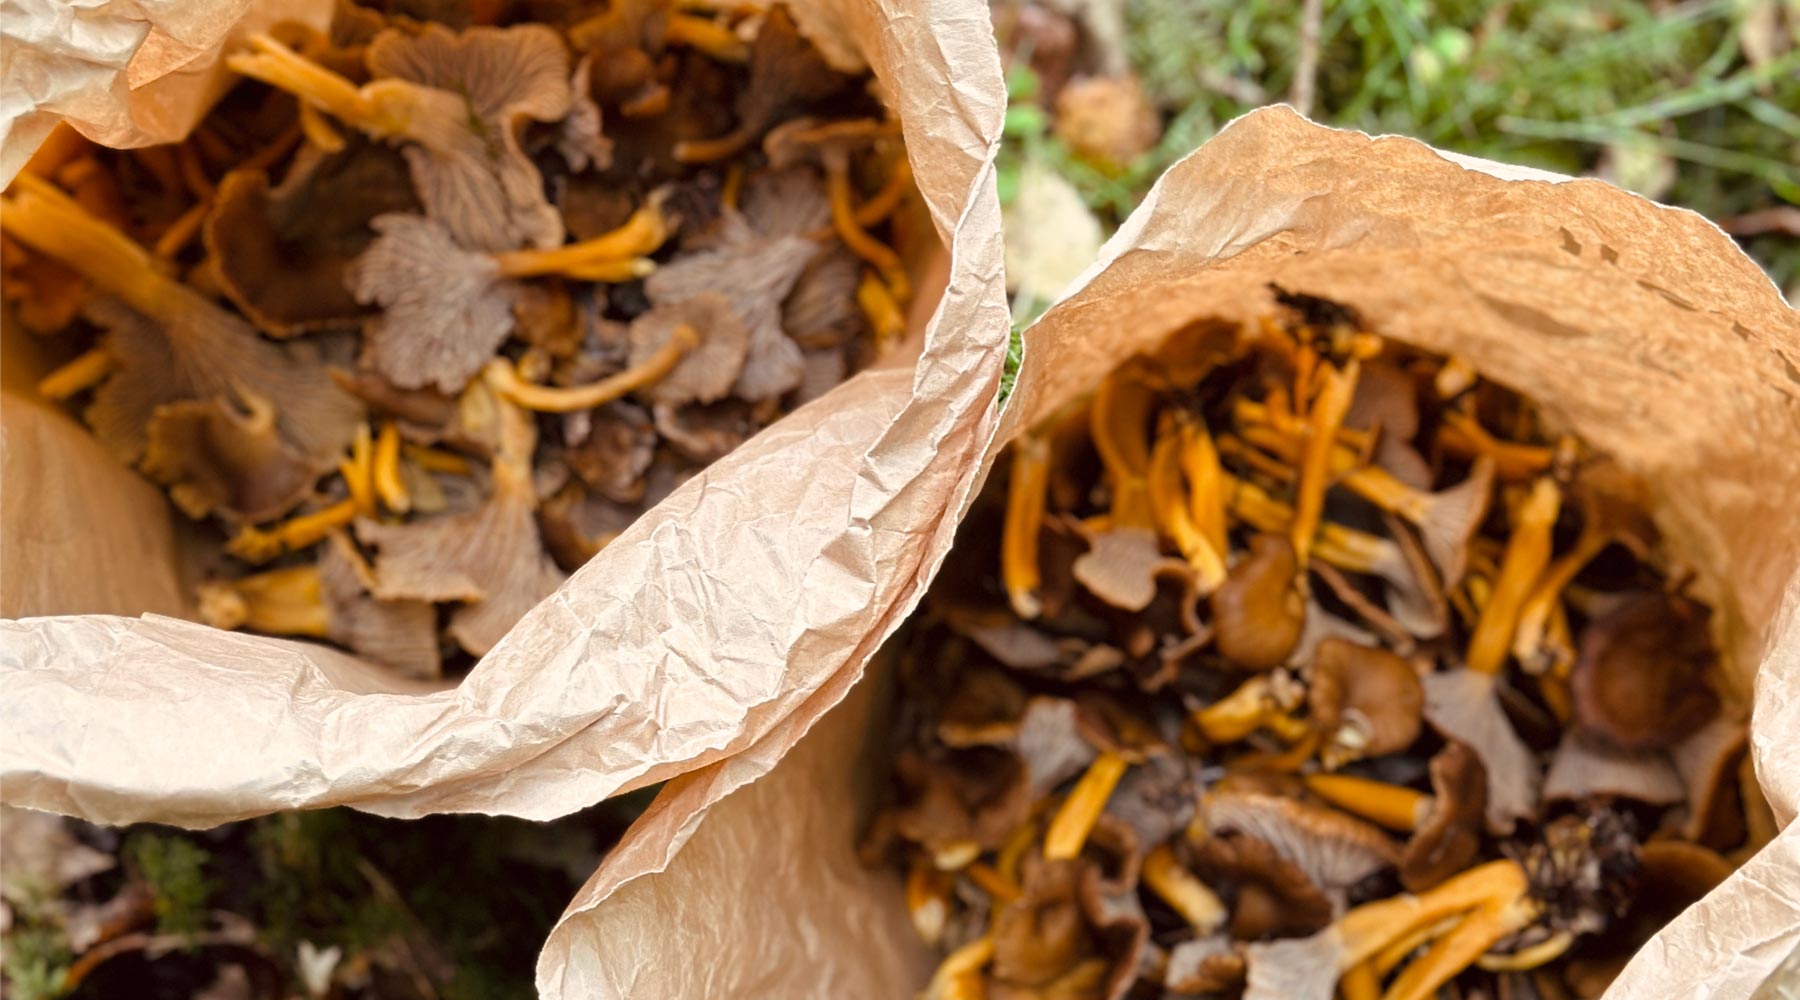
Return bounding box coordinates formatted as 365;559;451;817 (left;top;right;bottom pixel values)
1570;592;1719;750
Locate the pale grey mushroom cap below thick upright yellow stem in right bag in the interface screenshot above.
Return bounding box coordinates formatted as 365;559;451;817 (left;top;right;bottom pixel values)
1420;669;1543;833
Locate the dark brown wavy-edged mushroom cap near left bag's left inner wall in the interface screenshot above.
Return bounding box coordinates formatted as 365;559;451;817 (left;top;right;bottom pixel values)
139;394;319;522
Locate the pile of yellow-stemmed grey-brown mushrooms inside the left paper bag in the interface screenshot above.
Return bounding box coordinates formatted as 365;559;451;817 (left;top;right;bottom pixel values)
0;0;913;676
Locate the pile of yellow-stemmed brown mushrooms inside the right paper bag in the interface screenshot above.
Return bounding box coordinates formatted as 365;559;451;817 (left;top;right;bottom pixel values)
862;290;1773;1000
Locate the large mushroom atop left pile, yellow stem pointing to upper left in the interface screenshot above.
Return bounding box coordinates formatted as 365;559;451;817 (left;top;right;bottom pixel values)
227;25;572;254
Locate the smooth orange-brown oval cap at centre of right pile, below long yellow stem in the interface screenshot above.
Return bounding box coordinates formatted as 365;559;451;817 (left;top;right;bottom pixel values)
1211;534;1307;671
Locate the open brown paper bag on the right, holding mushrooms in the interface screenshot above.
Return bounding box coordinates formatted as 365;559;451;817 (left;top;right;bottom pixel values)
568;108;1800;1000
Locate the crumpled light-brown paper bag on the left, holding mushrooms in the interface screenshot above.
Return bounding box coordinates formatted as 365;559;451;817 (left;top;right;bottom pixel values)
0;0;1010;826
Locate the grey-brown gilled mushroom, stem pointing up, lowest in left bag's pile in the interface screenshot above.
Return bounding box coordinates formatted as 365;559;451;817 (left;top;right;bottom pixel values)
356;388;563;656
